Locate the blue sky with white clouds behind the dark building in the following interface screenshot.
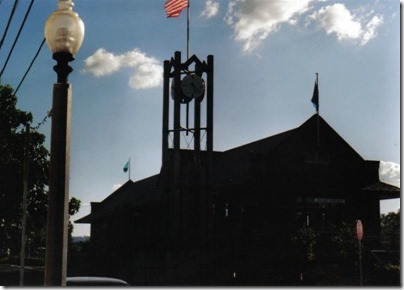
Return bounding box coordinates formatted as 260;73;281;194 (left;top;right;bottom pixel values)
0;0;400;235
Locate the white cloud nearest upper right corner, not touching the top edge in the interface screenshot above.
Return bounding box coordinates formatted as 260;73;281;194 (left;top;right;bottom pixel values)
309;3;383;45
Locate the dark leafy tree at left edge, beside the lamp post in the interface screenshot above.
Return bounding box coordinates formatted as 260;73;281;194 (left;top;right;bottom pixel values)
0;84;80;257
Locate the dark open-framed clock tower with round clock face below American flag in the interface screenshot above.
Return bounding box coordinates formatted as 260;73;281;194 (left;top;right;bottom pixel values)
160;51;213;270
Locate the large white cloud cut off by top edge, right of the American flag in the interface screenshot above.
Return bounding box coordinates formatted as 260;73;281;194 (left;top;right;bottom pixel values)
225;0;313;52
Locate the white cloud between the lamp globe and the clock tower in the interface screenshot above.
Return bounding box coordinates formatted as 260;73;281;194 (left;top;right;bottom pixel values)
83;48;163;89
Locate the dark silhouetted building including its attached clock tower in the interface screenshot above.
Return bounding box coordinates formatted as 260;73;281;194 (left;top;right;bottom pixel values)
76;52;400;286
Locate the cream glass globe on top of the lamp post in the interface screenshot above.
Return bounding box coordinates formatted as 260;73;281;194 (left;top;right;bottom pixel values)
45;0;84;56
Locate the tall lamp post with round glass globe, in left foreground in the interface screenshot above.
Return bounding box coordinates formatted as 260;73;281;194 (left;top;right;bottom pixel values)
45;0;84;286
